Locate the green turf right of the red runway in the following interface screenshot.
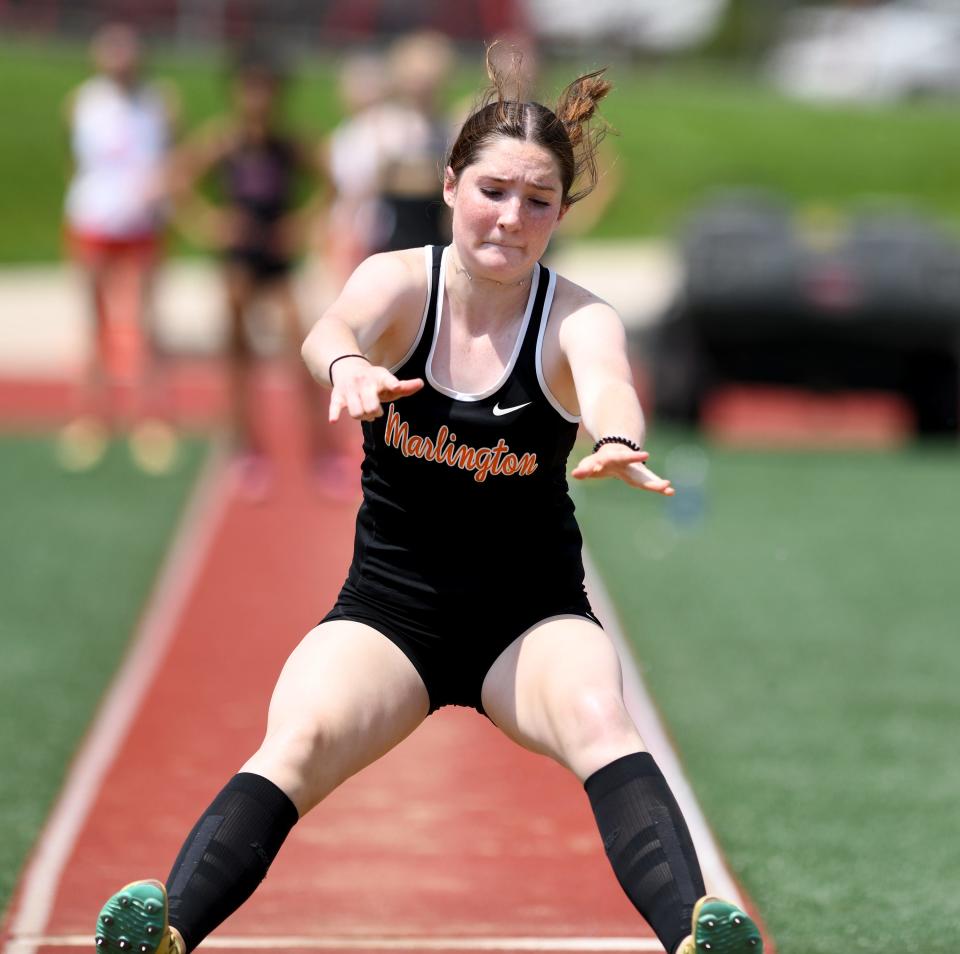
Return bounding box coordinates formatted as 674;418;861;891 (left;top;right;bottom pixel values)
578;435;960;954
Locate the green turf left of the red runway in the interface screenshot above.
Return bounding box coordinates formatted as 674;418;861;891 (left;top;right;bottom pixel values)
0;436;203;912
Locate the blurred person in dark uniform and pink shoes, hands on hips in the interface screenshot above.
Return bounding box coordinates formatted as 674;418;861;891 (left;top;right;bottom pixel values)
173;47;355;499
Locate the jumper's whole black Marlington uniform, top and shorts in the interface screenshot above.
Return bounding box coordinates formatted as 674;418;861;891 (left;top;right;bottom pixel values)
325;246;596;711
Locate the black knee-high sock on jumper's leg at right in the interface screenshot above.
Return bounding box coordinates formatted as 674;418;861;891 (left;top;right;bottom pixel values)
584;752;705;952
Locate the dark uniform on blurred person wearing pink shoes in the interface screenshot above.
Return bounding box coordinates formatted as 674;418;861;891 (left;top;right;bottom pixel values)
220;136;299;283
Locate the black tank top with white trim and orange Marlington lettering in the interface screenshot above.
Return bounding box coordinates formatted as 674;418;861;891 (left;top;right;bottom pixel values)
350;246;583;605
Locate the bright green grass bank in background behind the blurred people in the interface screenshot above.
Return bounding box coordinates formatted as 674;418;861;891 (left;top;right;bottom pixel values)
0;40;960;262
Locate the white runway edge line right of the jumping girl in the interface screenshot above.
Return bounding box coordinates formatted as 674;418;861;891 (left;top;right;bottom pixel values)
583;549;743;907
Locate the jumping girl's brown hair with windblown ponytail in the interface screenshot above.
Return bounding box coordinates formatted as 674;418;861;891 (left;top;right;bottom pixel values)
447;46;613;205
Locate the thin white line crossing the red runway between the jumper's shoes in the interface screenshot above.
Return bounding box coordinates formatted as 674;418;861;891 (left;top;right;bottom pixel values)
13;934;663;954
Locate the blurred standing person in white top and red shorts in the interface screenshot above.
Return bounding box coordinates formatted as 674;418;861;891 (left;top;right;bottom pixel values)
57;23;177;474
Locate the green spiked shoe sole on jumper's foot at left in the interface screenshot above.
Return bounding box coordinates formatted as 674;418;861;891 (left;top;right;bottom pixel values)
96;881;183;954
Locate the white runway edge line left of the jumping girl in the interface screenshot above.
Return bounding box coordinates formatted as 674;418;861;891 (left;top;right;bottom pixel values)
5;448;229;954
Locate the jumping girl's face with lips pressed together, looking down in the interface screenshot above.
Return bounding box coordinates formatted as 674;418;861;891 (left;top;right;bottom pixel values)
443;138;566;282
